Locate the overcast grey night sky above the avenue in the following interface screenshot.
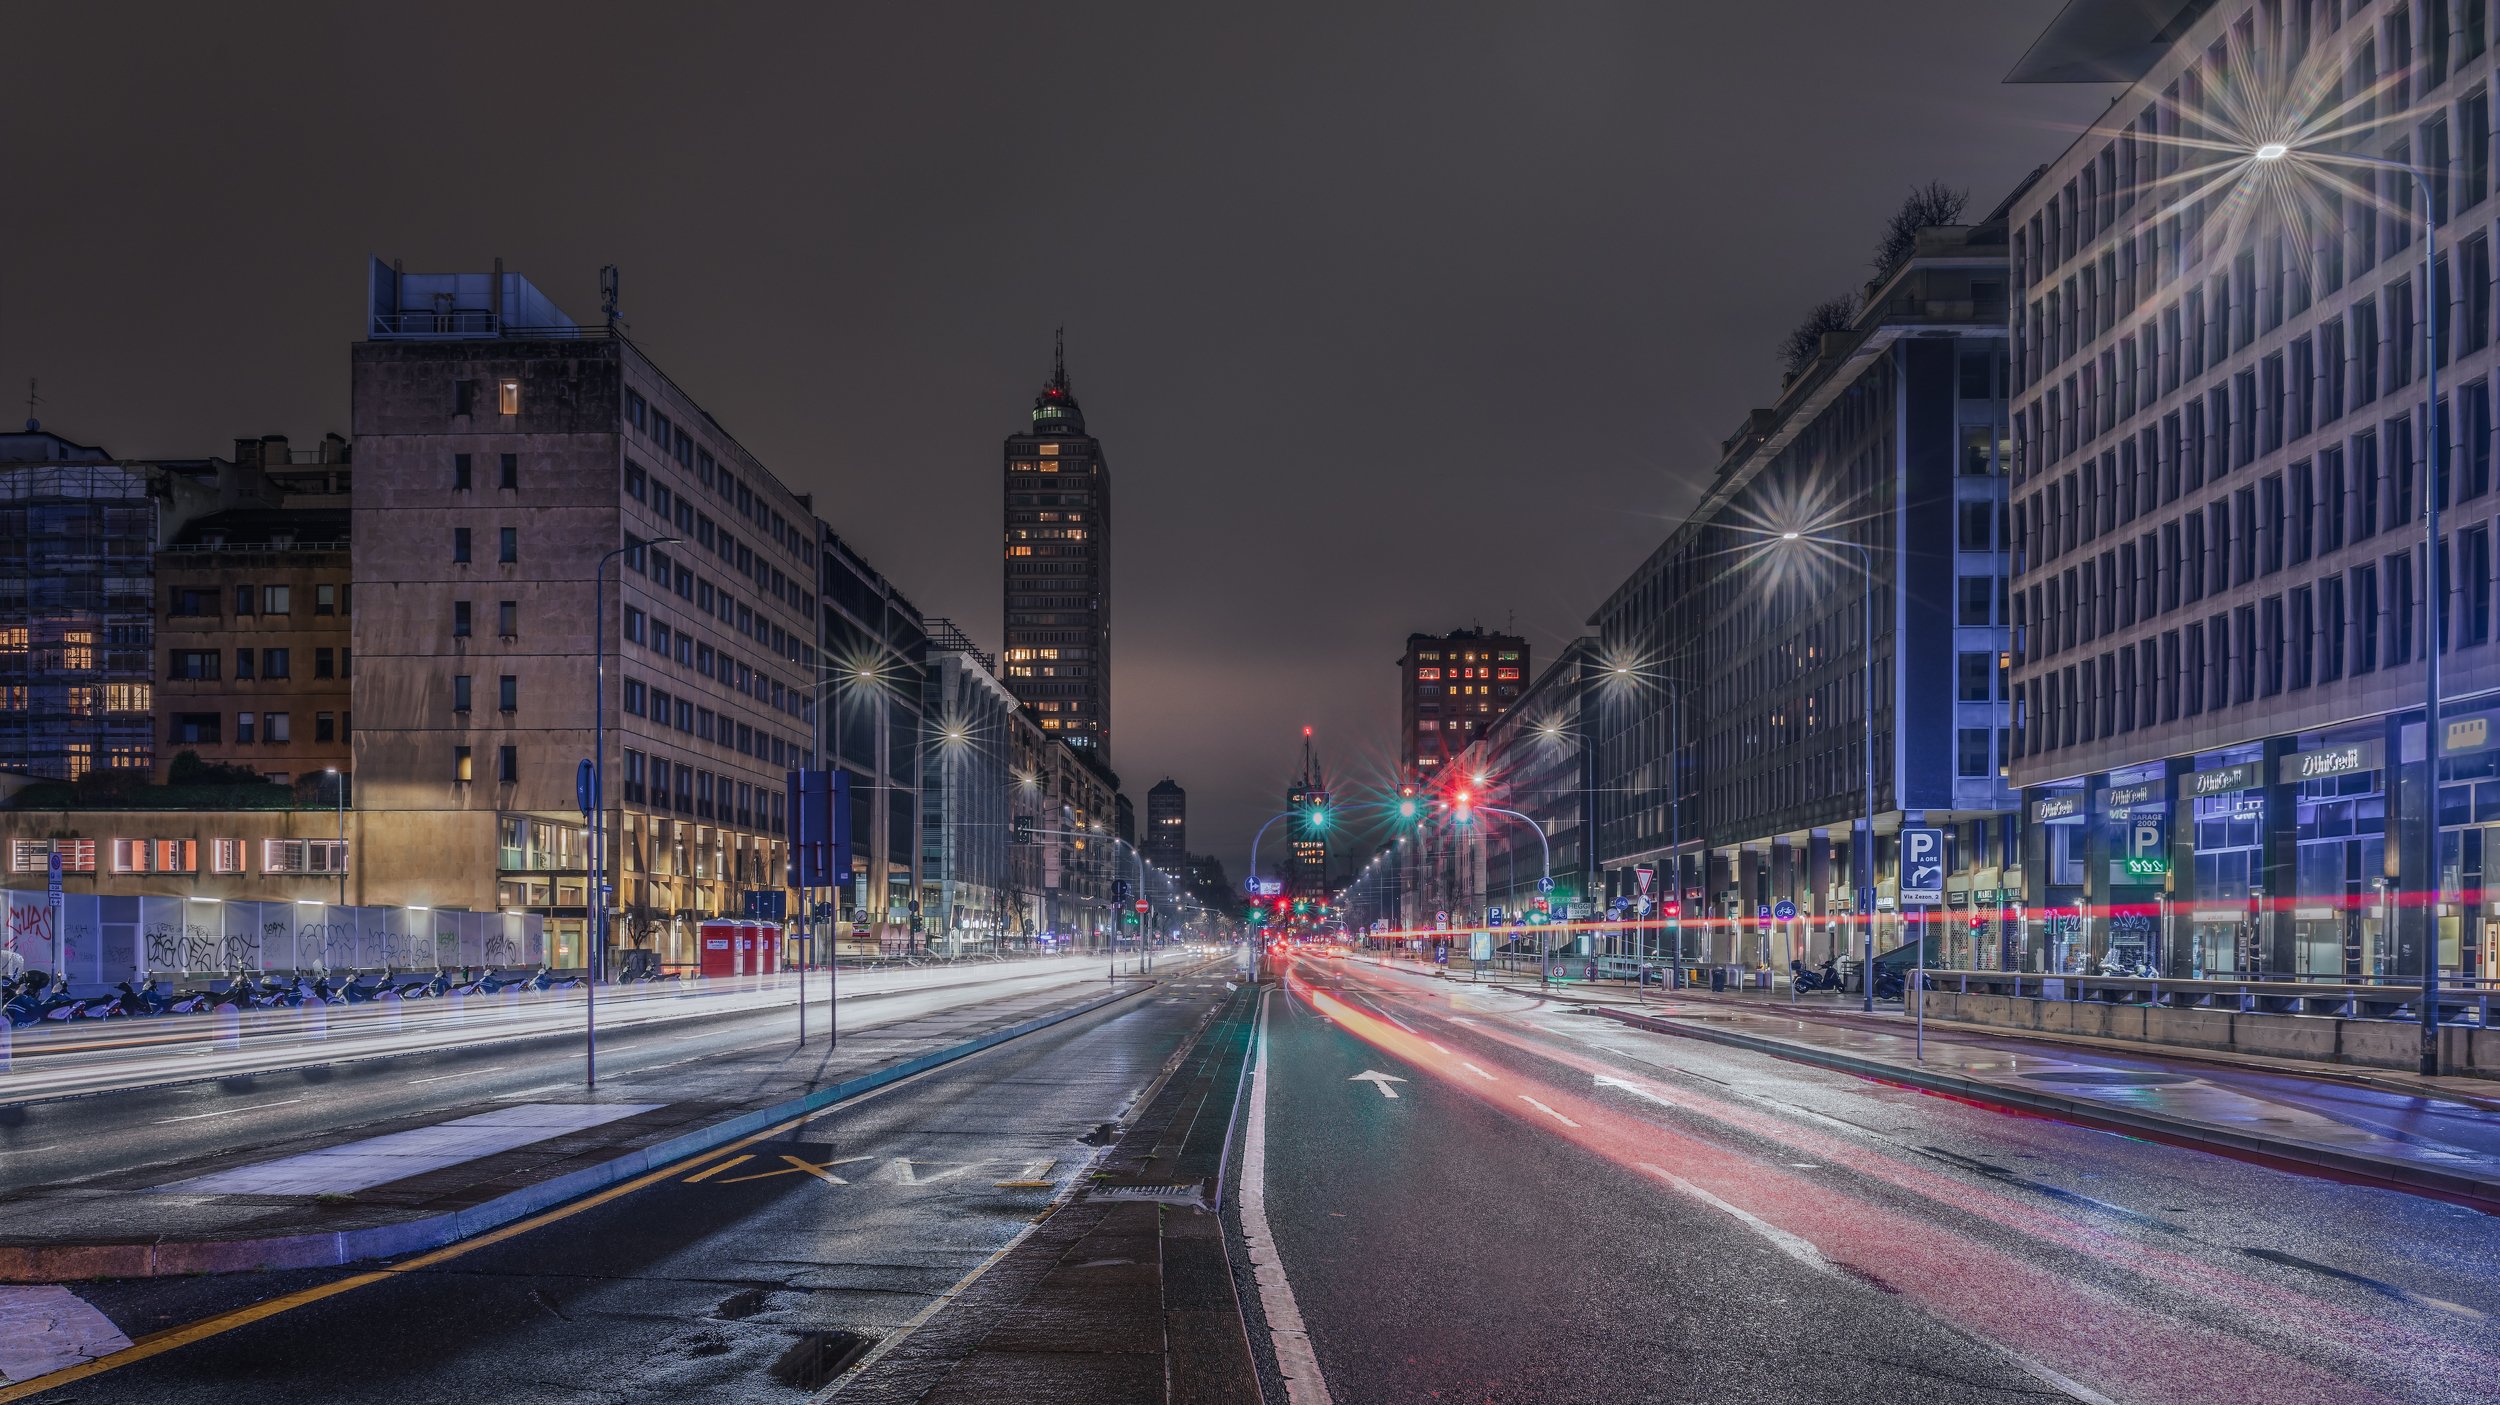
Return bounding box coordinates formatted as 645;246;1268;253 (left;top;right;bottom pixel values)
0;0;2113;878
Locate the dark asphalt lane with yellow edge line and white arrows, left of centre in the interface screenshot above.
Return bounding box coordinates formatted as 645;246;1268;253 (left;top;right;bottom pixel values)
4;973;1245;1405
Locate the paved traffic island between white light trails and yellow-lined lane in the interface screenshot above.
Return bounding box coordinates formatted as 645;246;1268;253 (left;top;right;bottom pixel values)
0;980;1153;1283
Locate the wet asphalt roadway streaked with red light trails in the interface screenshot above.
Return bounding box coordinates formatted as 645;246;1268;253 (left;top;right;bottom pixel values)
1265;963;2500;1405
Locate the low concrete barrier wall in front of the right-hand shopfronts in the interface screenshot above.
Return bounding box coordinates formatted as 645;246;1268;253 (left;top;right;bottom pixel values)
1928;990;2500;1078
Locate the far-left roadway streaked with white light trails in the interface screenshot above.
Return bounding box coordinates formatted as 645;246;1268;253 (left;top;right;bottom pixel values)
0;963;1135;1190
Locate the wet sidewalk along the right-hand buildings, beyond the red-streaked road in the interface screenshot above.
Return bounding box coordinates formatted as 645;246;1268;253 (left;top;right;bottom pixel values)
1393;968;2500;1213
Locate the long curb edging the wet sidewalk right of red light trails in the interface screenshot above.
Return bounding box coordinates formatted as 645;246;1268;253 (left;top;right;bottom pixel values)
1590;1010;2500;1213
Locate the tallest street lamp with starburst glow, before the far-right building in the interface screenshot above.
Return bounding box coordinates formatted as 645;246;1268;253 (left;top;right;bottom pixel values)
2250;143;2448;1078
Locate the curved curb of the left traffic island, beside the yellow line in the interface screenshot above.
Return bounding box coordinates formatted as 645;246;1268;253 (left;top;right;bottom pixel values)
0;983;1160;1283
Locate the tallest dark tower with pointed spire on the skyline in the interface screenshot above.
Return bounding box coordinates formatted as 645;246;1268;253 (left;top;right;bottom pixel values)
1005;338;1110;765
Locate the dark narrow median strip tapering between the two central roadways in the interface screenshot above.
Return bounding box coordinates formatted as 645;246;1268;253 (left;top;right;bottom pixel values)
830;985;1260;1405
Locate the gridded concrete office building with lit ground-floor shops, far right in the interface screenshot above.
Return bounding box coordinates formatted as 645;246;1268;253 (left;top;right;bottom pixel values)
2013;0;2500;980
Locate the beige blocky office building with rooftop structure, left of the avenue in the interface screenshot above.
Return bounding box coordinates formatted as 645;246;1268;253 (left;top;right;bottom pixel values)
350;260;820;965
